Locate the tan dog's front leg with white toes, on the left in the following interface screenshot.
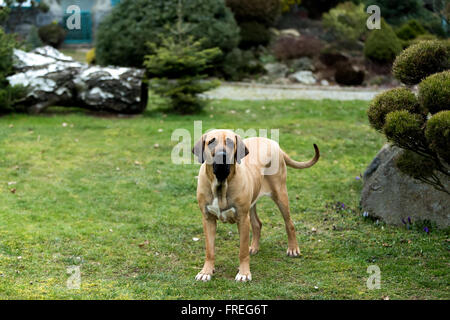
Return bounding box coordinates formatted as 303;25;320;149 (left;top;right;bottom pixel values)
195;212;217;281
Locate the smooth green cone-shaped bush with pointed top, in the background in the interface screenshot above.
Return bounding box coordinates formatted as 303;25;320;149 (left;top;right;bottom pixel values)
364;20;402;63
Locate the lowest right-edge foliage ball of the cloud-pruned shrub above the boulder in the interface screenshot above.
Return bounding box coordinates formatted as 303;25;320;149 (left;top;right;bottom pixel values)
425;110;450;163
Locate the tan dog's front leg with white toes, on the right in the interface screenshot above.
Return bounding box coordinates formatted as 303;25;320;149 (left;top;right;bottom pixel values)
235;212;252;282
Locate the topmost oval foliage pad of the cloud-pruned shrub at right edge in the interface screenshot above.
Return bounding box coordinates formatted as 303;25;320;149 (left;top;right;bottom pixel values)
393;41;450;85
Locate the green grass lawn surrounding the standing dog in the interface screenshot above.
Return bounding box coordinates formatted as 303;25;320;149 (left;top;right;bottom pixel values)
0;100;450;299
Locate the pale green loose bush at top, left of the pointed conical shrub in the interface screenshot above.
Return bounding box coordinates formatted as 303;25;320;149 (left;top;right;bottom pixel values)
322;2;368;41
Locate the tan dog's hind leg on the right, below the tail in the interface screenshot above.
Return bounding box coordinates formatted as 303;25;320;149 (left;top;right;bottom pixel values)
272;185;300;257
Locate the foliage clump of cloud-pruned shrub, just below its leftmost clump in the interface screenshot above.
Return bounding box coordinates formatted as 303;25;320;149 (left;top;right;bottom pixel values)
383;110;425;147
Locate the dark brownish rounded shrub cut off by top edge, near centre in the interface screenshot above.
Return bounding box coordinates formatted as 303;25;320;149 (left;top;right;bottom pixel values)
226;0;282;27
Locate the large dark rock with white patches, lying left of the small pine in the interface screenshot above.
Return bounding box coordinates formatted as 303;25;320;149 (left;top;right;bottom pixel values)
7;46;148;114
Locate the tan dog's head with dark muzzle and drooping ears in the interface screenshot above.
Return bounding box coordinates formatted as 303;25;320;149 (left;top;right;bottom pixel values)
192;130;248;181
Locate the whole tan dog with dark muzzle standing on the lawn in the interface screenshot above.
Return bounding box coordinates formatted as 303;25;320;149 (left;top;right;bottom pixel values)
192;130;320;281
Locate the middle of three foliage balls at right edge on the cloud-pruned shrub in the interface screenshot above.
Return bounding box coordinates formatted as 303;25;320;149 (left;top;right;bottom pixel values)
419;71;450;114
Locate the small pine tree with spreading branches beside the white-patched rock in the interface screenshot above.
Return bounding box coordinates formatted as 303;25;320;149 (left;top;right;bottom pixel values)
144;0;221;113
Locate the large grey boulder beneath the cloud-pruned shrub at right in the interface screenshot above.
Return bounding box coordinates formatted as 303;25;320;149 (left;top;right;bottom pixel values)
361;145;450;228
